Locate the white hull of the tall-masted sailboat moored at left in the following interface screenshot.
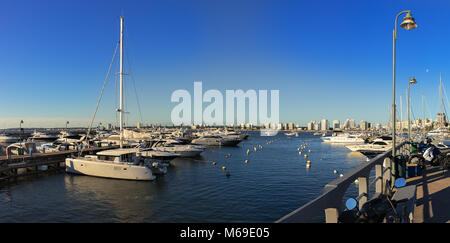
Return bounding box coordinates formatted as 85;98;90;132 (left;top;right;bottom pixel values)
66;158;155;181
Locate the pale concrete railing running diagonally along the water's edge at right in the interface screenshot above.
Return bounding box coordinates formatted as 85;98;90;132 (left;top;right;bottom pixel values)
275;142;409;223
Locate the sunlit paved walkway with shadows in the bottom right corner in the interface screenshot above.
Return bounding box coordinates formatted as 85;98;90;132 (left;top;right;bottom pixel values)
407;167;450;223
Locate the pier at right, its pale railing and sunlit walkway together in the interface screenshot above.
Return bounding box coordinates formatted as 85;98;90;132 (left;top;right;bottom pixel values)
276;142;450;223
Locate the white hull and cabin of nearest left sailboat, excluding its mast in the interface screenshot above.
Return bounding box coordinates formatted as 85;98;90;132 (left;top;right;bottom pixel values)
66;149;156;181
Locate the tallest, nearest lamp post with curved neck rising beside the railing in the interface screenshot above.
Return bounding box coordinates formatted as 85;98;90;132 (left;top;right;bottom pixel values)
392;10;417;159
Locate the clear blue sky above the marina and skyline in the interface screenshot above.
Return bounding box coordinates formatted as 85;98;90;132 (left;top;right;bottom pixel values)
0;0;450;128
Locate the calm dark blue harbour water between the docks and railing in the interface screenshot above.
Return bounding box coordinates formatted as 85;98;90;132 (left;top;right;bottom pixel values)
0;133;366;223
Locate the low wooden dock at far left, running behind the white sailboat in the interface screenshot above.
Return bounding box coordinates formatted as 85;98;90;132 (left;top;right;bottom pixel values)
0;146;119;180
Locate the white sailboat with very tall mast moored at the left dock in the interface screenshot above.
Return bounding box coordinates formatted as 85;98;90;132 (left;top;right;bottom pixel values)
65;16;156;181
